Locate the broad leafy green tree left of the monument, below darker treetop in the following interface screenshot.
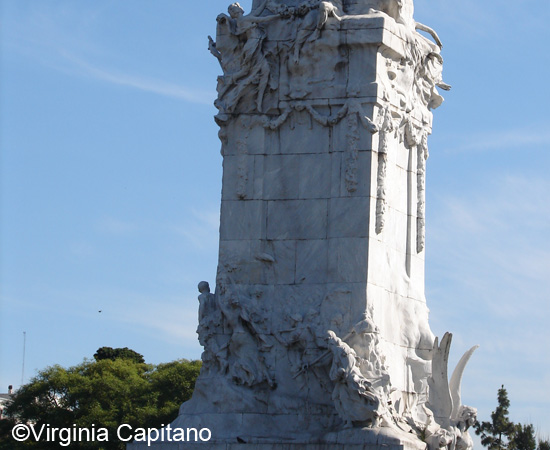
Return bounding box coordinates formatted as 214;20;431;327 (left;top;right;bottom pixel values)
0;357;201;450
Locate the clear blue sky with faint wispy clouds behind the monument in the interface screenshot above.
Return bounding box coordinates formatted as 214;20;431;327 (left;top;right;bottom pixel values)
0;0;550;438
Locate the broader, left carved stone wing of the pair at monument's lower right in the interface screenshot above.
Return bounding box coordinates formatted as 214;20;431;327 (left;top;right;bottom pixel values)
428;333;453;428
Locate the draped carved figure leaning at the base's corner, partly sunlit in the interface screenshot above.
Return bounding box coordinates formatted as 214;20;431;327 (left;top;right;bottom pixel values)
328;330;382;428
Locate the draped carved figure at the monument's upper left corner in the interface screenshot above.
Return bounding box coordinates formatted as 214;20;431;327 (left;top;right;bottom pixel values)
215;0;280;112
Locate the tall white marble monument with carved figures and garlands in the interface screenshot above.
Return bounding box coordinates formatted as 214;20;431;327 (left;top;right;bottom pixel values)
129;0;476;450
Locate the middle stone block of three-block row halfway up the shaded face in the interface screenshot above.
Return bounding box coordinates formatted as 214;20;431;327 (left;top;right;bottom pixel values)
267;200;328;239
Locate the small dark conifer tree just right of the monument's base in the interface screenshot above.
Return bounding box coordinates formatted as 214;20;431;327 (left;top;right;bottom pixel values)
475;386;516;450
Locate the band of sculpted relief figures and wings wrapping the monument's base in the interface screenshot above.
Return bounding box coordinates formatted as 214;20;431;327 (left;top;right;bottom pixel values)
197;278;477;450
